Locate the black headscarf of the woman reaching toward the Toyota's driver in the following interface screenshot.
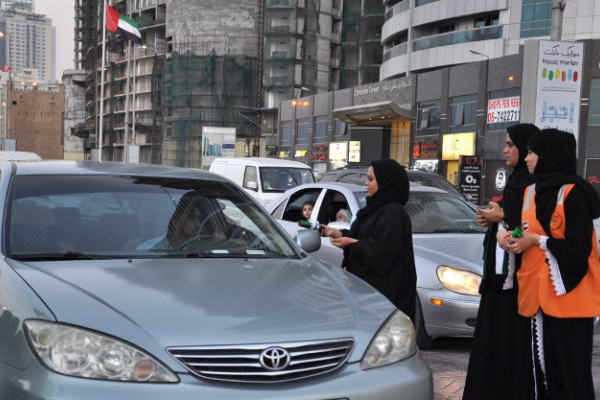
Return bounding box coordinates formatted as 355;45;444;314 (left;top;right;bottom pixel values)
350;158;410;237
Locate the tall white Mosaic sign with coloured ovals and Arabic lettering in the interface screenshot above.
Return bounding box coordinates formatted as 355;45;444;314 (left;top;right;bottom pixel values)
534;40;583;139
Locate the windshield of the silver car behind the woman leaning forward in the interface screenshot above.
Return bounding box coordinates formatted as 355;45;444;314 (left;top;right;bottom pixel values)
405;191;485;233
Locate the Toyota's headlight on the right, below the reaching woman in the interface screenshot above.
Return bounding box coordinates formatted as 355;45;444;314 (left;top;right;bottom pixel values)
360;311;417;369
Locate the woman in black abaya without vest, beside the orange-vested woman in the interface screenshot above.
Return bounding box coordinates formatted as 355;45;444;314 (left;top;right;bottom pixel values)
463;124;539;400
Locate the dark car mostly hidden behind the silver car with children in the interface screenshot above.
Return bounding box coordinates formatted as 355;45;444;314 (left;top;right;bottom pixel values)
319;168;468;200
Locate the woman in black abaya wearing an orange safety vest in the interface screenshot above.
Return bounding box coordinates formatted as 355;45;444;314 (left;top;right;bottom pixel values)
506;129;600;400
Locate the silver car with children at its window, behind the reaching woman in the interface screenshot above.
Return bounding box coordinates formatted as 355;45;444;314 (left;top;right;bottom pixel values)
268;182;485;348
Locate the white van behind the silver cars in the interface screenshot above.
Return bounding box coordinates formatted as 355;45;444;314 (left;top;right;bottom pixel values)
210;157;315;206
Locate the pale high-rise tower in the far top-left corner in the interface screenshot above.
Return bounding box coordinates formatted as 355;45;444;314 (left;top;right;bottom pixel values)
0;8;56;80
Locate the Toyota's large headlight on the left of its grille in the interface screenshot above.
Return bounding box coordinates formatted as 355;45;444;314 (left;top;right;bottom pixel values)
24;320;179;382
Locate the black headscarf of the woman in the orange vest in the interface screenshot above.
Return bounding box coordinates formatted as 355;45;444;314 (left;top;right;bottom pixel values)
529;129;600;235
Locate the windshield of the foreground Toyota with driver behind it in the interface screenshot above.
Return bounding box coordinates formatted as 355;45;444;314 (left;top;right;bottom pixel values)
4;175;296;260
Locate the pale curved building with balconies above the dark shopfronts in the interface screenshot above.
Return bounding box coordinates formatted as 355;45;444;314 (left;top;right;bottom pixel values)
380;0;600;80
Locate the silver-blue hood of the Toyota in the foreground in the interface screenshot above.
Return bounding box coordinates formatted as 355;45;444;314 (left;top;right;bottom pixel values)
9;257;394;368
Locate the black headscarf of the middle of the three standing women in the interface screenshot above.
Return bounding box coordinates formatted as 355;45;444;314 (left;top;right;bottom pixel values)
501;124;539;230
